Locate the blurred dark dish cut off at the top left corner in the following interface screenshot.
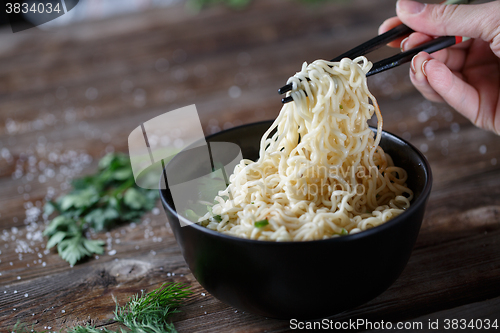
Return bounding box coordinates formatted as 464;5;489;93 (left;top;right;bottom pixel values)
0;0;79;33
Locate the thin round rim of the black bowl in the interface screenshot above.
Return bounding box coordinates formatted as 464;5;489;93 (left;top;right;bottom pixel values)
159;120;433;246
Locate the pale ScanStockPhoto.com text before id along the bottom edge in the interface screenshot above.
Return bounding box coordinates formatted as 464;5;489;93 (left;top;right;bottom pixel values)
290;318;424;331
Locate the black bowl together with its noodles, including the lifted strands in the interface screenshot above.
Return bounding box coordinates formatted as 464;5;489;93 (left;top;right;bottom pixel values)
160;57;432;319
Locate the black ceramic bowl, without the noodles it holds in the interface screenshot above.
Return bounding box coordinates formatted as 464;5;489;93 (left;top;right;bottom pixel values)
161;121;432;319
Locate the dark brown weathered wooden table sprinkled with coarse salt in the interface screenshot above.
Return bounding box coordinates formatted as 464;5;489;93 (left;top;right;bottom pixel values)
0;0;500;332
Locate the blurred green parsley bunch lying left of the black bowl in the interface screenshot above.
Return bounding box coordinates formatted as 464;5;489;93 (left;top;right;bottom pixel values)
44;154;159;265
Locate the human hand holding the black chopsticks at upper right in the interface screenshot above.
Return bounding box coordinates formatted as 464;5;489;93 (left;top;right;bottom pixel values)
379;0;500;135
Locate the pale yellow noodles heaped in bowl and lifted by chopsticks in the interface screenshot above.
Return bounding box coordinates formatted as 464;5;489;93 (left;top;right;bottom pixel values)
199;57;413;241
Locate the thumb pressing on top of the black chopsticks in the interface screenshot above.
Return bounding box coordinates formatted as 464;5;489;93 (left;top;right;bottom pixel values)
396;0;500;43
